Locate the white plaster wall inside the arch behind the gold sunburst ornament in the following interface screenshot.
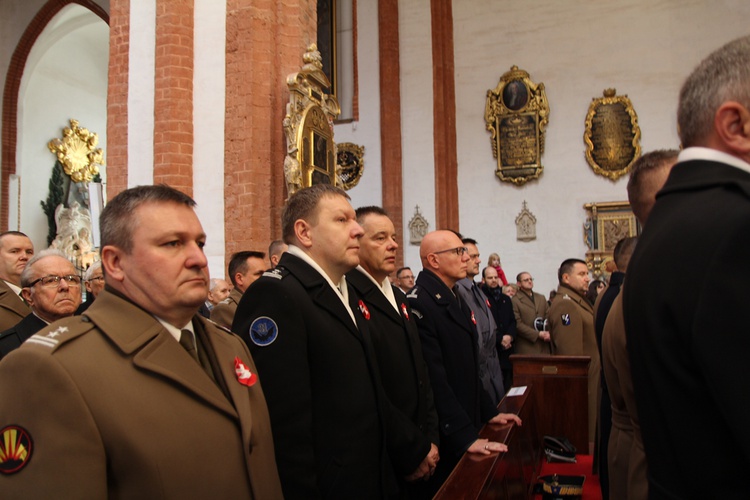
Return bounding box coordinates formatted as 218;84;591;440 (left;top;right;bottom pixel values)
16;5;109;249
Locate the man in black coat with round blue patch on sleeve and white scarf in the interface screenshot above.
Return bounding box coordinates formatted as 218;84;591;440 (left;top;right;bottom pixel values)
232;185;430;499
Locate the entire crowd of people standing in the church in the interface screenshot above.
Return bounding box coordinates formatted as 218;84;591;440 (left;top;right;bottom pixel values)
0;37;750;499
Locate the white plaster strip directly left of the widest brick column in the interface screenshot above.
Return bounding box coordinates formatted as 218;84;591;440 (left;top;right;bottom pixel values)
193;0;226;278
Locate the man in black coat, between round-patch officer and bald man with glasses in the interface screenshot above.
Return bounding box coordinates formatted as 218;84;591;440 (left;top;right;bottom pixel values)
346;207;439;498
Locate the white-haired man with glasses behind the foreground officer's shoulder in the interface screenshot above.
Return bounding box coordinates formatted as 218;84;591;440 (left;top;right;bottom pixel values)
0;250;81;359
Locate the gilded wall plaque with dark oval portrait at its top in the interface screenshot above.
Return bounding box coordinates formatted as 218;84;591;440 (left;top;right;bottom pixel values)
484;66;549;185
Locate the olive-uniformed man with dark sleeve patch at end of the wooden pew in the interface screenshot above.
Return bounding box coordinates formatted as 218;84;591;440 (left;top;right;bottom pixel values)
549;259;601;443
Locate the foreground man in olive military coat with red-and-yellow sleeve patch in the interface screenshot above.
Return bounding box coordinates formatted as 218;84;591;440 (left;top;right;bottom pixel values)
0;185;282;500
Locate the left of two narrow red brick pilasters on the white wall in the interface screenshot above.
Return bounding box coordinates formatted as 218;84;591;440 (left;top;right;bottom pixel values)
378;0;404;267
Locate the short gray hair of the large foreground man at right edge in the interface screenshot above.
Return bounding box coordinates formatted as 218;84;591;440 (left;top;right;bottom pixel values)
677;36;750;147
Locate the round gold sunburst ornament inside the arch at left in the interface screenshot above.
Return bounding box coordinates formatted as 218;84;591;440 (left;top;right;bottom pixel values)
47;119;104;182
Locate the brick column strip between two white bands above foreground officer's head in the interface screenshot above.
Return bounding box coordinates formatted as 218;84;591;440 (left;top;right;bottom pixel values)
154;0;194;196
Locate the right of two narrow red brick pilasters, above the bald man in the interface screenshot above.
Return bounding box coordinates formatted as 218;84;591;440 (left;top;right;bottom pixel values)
430;0;459;231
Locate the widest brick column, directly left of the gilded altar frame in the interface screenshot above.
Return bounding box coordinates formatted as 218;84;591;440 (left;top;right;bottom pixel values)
224;0;317;261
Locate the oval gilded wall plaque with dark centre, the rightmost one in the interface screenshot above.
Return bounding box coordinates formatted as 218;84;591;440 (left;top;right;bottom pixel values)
583;89;641;181
